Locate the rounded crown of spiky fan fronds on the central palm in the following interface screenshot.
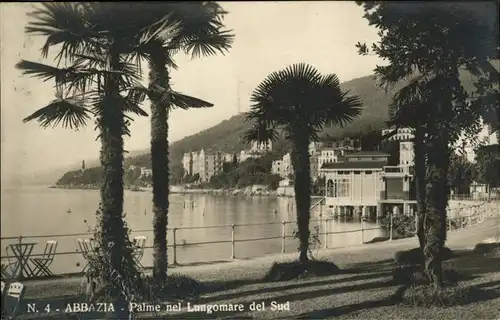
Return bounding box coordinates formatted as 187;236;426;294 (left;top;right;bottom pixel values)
250;63;361;139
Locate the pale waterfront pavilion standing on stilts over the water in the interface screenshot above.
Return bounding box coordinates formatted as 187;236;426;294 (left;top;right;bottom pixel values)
320;151;416;216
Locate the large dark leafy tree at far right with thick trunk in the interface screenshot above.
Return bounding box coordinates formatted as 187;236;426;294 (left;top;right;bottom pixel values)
358;1;498;287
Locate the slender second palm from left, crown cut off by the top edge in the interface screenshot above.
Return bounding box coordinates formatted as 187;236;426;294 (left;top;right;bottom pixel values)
127;2;233;283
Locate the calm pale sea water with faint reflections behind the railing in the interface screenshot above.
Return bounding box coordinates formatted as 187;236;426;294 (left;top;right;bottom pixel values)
1;188;383;273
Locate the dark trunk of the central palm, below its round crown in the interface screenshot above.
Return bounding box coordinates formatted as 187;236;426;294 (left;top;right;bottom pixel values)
292;134;311;262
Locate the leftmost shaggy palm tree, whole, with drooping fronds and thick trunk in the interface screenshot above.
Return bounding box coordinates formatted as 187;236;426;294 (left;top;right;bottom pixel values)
17;3;179;318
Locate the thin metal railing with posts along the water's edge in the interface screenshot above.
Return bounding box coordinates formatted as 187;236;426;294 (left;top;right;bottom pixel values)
0;199;498;278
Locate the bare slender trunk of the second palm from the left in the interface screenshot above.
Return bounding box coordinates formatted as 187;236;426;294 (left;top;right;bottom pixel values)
149;46;170;283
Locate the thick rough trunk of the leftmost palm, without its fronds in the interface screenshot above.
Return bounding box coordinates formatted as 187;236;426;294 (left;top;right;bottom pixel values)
100;47;133;318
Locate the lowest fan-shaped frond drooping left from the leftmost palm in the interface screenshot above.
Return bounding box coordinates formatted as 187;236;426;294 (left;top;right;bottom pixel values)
23;99;91;130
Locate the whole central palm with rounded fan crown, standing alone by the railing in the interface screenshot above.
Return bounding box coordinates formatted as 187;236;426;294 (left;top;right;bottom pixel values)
244;63;361;262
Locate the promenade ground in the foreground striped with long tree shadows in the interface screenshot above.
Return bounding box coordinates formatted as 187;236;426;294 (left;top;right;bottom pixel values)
13;219;500;319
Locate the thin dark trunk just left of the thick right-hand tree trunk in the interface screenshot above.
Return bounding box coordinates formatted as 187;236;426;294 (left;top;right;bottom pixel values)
414;126;426;253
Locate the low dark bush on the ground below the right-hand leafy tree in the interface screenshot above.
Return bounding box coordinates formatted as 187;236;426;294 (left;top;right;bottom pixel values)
401;285;483;307
